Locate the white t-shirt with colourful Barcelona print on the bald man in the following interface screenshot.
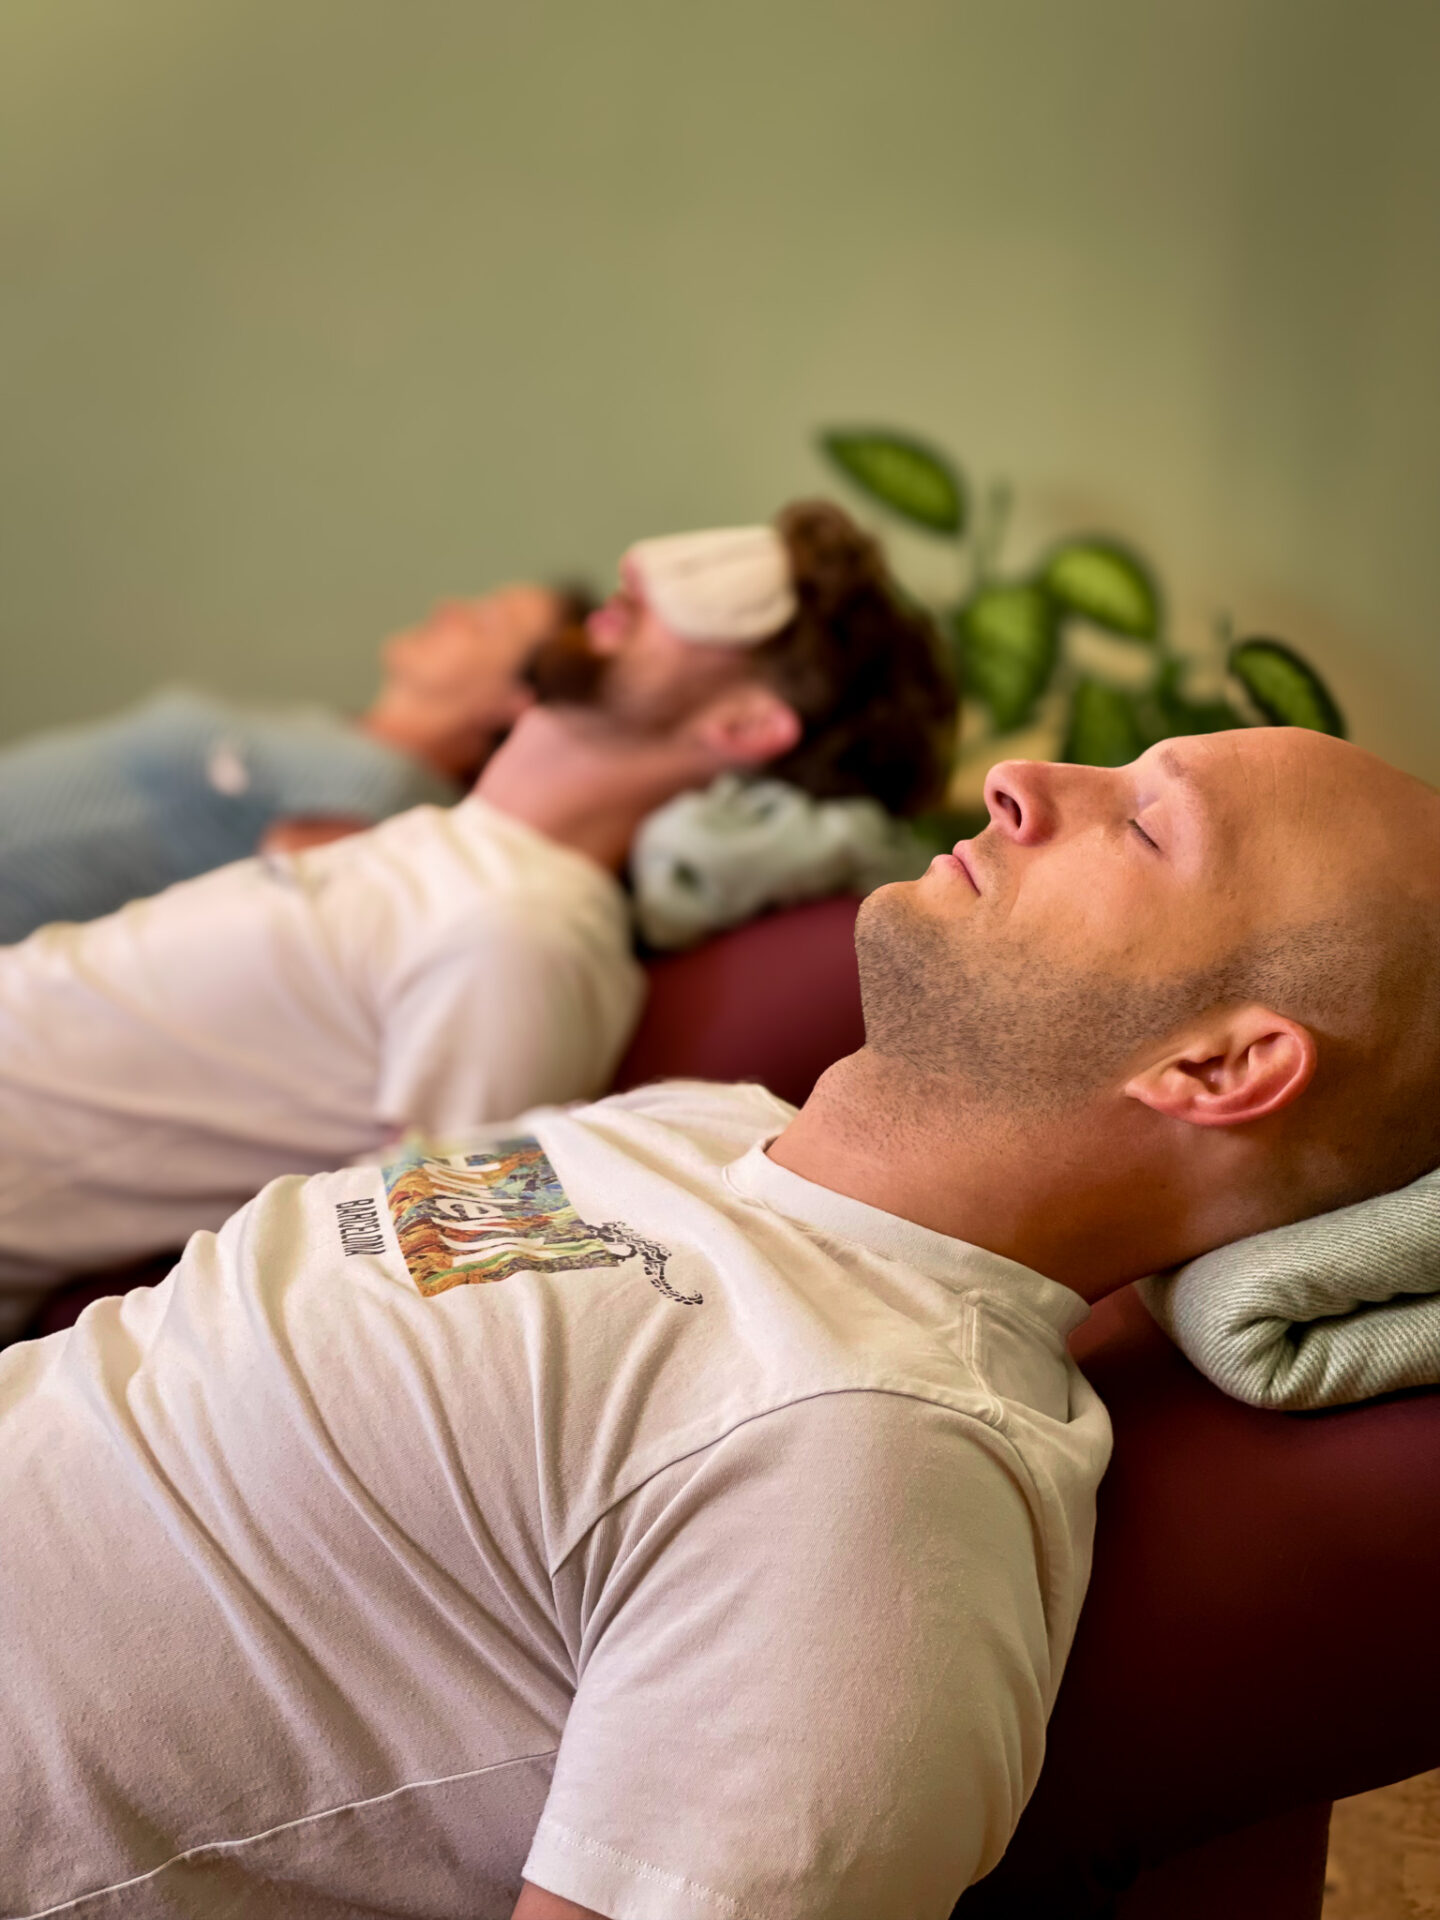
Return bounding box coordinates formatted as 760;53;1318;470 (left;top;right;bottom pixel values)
0;1083;1110;1920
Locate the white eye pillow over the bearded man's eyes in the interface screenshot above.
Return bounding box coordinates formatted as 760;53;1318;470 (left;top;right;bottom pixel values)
626;526;799;647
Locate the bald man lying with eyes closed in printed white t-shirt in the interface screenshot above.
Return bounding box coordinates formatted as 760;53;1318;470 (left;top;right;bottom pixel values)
0;730;1440;1920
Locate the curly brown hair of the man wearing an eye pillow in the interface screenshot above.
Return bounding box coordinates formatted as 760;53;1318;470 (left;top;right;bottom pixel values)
751;499;960;814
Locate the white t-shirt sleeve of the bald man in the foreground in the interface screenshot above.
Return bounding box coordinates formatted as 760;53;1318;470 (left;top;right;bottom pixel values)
524;1392;1052;1920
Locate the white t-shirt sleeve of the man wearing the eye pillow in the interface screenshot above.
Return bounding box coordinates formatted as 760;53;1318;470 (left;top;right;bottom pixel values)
380;897;643;1135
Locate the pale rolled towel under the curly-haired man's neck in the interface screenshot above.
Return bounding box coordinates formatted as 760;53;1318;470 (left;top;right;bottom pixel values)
630;774;933;947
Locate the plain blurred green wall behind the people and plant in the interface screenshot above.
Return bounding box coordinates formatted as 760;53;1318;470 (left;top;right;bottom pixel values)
0;0;1440;778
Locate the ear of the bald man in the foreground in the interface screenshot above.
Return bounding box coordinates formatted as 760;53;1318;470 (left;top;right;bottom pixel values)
1125;1006;1315;1127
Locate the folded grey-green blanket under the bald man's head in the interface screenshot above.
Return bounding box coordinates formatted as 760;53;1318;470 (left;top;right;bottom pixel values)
1139;1171;1440;1411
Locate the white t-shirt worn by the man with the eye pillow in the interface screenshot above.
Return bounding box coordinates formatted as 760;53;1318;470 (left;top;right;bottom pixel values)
0;799;643;1334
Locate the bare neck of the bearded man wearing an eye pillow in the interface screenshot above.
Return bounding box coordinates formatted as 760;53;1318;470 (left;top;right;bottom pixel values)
474;707;720;874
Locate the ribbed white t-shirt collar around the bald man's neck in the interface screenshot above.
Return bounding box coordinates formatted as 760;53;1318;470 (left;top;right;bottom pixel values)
726;1133;1091;1334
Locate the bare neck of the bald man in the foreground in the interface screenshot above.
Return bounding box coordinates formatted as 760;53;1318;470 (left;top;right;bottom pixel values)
770;1046;1309;1300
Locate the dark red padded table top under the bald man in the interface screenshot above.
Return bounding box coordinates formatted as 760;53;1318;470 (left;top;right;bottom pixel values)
956;1288;1440;1920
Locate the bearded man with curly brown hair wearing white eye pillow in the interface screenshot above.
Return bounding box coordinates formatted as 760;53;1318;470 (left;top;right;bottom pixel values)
0;501;956;1338
